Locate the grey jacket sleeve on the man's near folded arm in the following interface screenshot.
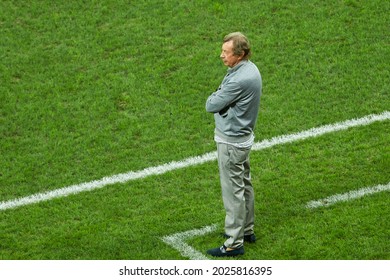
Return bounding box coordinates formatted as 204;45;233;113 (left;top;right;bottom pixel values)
206;81;242;113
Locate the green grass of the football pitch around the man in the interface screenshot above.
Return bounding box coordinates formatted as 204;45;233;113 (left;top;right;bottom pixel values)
0;0;390;260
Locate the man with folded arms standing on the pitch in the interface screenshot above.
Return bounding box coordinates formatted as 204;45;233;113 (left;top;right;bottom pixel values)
206;32;262;257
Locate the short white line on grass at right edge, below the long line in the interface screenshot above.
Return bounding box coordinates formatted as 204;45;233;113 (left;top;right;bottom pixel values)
306;182;390;209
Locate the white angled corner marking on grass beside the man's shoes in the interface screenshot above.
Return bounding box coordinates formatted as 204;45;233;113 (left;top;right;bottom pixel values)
161;225;217;260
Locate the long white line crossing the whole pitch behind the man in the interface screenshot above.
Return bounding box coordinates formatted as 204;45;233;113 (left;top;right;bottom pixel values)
0;111;390;211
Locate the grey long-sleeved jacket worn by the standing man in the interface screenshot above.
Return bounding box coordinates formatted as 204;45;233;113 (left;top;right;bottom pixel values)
206;60;262;143
